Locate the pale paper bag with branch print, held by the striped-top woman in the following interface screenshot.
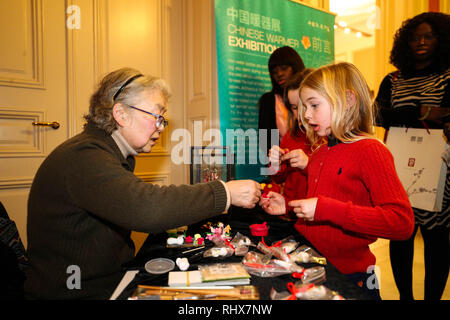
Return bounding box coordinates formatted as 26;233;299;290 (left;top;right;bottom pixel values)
386;127;448;212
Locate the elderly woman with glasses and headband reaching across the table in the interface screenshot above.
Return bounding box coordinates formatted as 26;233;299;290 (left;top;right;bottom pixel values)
25;68;261;299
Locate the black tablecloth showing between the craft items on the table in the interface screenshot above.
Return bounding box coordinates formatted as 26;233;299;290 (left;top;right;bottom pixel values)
118;207;371;300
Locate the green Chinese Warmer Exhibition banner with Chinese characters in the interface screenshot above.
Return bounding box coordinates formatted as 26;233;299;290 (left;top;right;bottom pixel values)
215;0;335;181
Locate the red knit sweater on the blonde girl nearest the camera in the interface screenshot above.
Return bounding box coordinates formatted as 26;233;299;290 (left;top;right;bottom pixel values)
295;139;414;274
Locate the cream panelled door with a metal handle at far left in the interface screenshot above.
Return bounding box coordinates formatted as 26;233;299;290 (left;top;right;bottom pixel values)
0;0;69;245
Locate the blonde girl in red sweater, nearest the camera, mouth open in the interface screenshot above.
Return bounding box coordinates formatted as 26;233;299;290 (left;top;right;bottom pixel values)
260;62;414;298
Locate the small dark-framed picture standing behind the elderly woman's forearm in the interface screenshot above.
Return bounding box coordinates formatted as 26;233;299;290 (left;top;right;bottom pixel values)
190;146;235;184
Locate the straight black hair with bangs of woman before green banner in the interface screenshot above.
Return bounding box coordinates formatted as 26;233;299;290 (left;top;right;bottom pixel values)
268;46;305;94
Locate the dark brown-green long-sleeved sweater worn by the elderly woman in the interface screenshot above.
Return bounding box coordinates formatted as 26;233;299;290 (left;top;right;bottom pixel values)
25;124;227;299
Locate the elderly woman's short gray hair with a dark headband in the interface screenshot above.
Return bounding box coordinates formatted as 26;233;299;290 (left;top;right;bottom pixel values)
84;68;170;134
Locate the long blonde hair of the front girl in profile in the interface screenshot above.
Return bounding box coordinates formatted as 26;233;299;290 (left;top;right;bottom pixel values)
299;62;375;146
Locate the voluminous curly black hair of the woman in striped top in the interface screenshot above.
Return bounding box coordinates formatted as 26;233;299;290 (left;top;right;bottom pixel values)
389;12;450;73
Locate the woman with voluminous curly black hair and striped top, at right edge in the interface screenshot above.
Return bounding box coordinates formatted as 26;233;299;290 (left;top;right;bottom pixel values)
375;12;450;300
